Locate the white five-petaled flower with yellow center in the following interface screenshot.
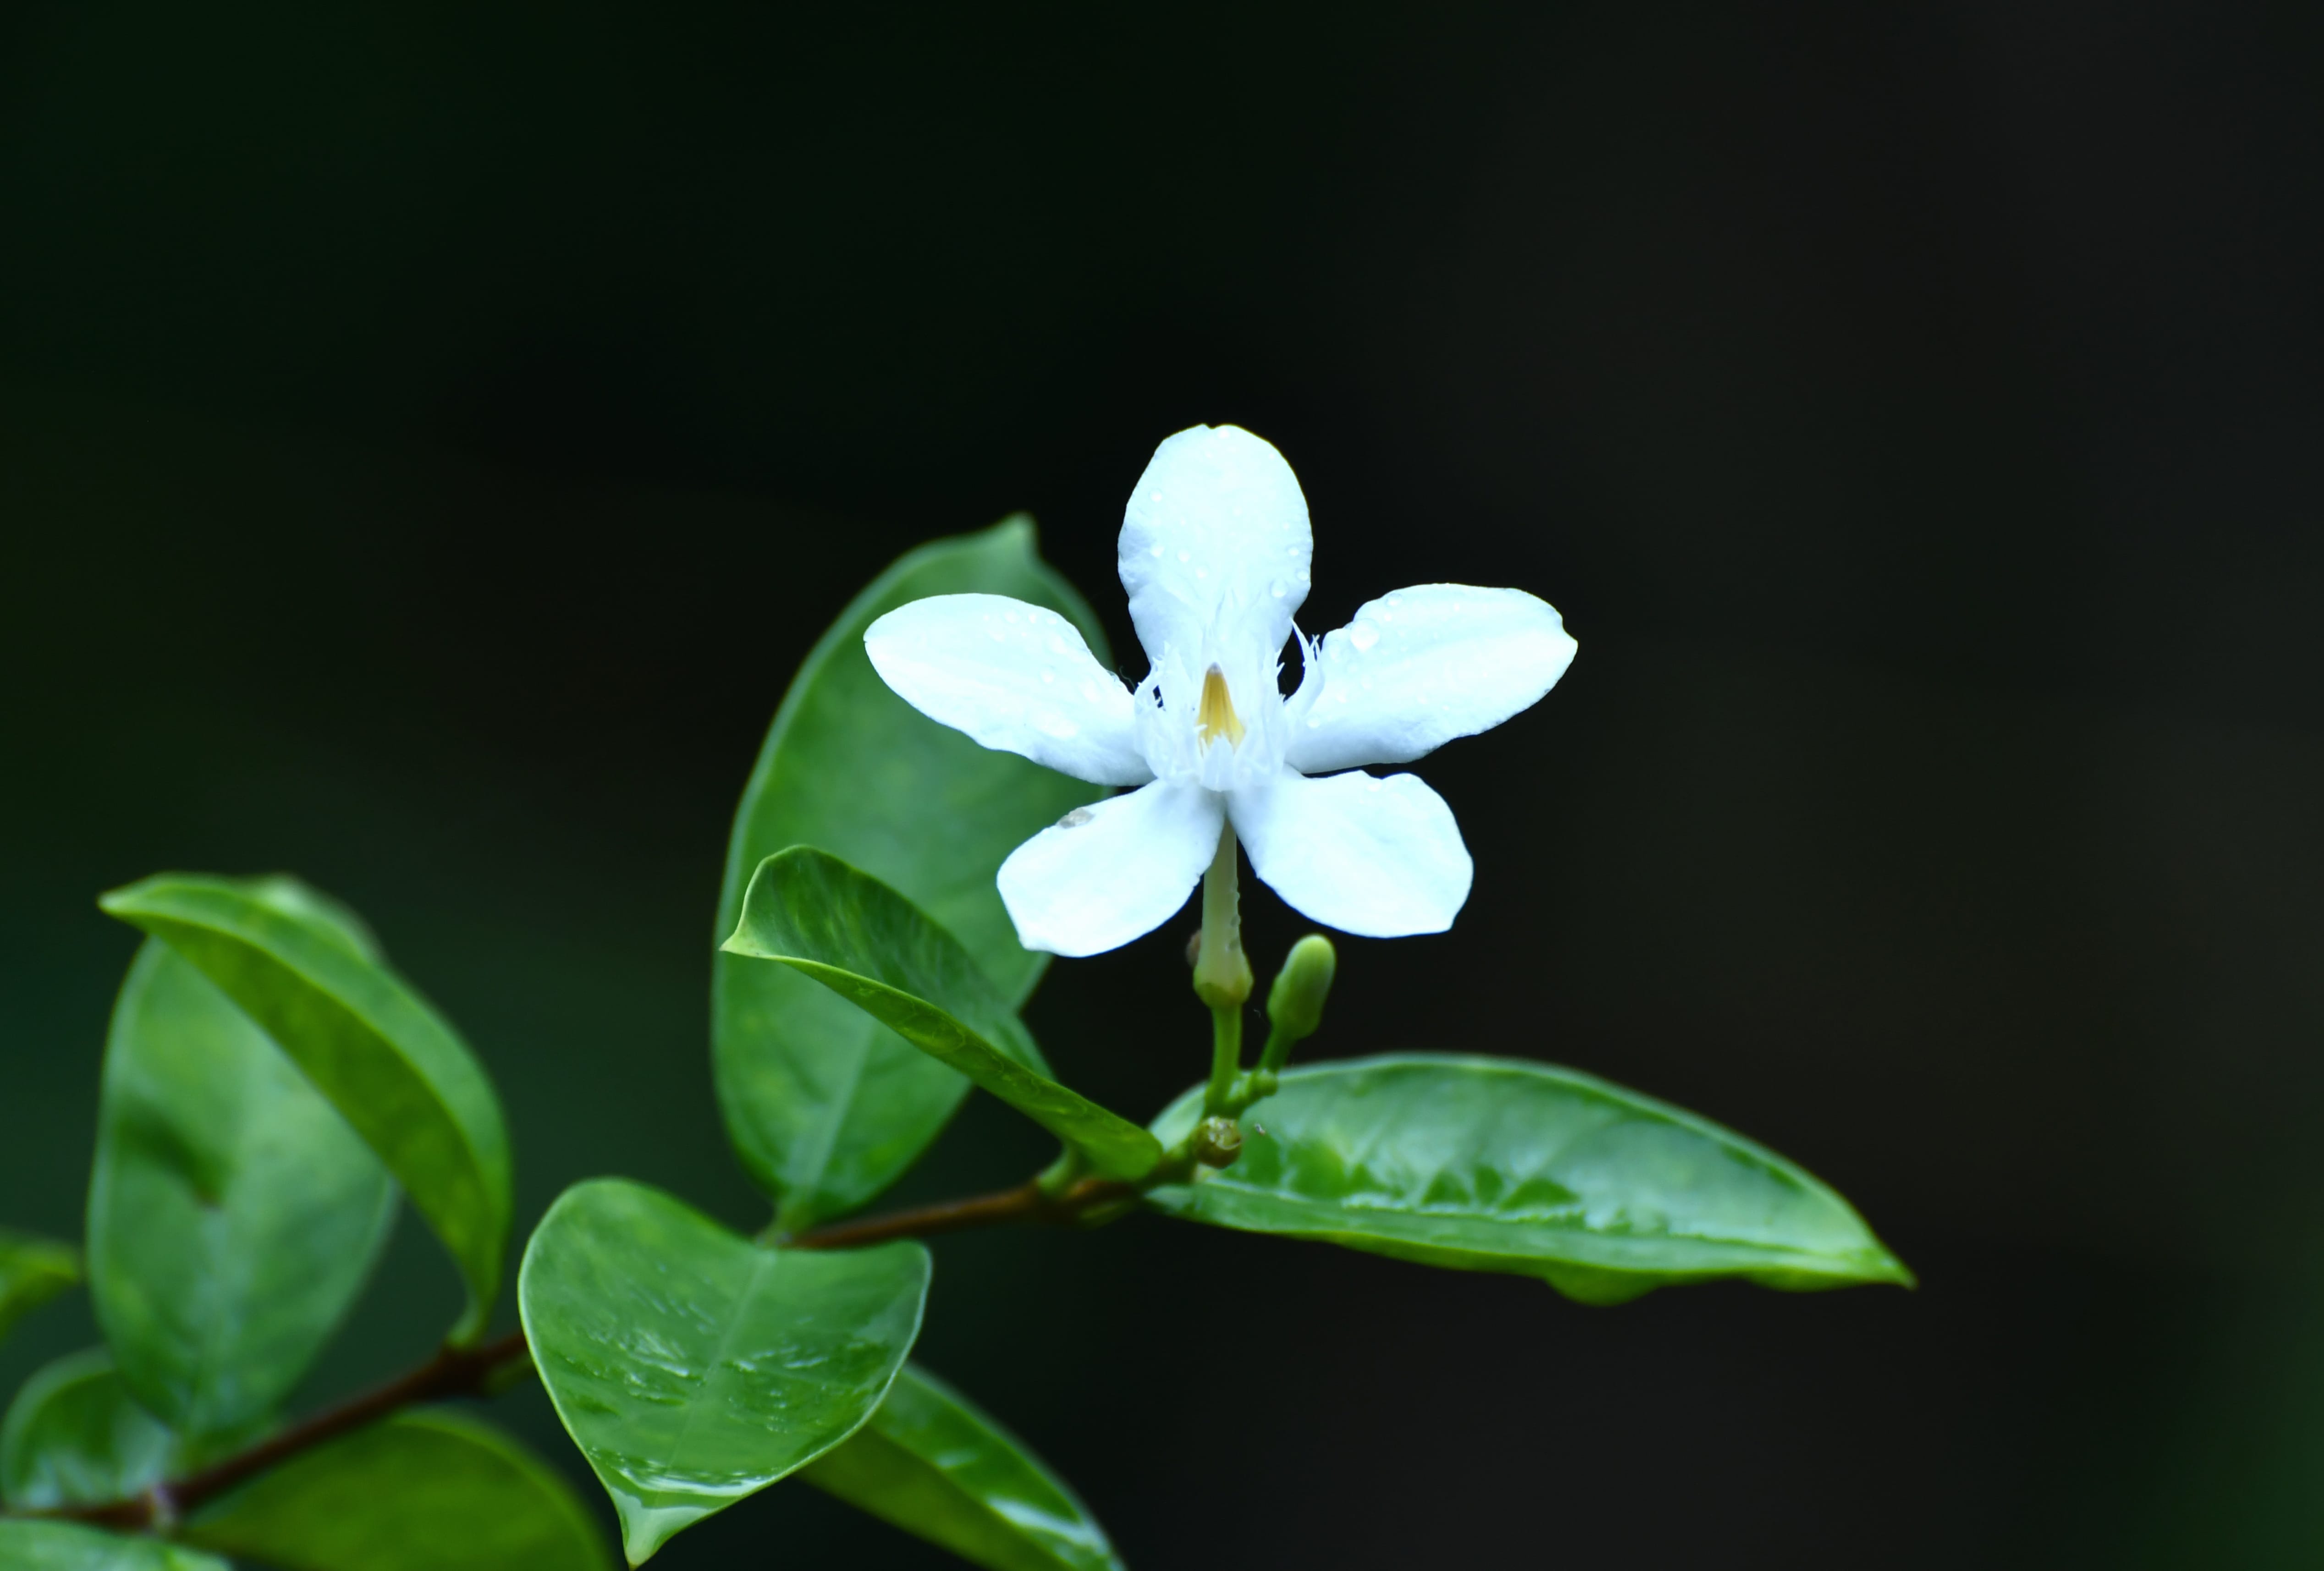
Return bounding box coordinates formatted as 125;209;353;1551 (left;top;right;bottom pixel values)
865;425;1573;955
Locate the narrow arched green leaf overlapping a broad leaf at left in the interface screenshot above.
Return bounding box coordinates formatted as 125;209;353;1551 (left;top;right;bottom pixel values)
98;874;509;1343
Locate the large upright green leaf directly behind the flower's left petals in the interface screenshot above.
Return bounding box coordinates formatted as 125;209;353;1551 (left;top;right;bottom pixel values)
711;518;1111;1232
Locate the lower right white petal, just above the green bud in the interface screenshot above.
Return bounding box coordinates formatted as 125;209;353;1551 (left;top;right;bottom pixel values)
1227;769;1473;939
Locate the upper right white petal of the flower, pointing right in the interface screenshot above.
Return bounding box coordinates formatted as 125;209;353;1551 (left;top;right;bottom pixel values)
1285;583;1573;774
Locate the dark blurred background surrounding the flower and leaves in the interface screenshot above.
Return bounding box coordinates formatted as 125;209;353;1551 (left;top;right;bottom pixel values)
0;0;2324;1569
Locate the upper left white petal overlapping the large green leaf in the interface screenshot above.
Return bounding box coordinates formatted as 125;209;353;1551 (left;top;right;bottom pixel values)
865;595;1153;786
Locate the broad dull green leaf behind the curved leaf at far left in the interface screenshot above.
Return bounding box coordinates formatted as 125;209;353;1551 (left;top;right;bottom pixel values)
88;939;395;1436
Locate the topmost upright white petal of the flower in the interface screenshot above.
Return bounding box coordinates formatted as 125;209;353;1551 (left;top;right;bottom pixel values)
1120;425;1316;681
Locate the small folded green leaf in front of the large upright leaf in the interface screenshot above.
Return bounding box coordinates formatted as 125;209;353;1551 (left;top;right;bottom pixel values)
725;846;1162;1181
